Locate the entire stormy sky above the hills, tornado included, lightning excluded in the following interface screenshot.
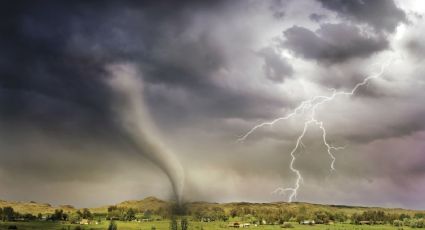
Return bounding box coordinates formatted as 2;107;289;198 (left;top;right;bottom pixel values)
0;0;425;209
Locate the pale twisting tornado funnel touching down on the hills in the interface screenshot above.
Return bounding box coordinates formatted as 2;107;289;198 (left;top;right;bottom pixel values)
106;64;184;204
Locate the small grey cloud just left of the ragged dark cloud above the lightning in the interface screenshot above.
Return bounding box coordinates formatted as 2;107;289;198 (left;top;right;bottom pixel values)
258;47;294;82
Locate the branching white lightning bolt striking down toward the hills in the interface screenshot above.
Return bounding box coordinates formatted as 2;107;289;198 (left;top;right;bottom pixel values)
238;59;394;202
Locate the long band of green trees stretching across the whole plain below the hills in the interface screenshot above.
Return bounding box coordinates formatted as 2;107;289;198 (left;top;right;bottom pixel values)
0;202;425;229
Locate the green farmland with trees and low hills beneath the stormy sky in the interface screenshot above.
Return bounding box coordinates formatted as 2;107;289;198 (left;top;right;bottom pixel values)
0;197;425;230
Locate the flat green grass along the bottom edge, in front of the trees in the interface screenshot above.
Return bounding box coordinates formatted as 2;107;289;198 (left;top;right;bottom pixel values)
0;221;410;230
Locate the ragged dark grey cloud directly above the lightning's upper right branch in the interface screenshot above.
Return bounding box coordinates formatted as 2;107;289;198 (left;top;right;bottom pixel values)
282;24;388;64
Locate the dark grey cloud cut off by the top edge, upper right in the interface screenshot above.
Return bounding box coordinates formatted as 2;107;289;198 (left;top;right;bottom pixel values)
319;0;407;32
